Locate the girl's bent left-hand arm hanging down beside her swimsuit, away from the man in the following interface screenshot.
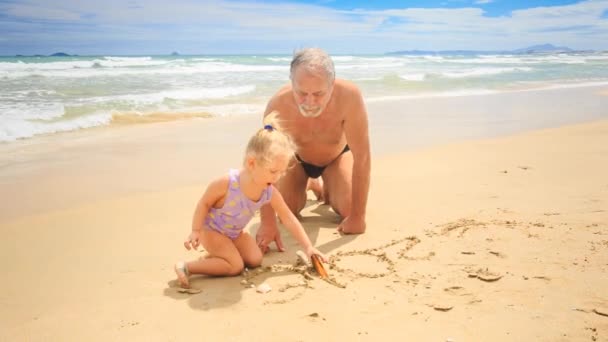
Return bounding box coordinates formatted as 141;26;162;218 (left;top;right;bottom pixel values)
184;176;230;249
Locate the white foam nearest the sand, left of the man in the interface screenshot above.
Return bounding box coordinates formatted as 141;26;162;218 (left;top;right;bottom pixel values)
0;85;256;142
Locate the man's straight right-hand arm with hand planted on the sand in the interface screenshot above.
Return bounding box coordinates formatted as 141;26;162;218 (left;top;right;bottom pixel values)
339;85;371;234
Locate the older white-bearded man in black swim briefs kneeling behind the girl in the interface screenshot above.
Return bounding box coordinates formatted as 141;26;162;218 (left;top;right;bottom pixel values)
257;48;371;253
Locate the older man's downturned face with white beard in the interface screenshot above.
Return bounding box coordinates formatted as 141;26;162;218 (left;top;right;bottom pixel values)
291;67;333;118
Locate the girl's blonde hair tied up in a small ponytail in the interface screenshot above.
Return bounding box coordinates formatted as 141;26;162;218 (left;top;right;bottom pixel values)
245;111;296;165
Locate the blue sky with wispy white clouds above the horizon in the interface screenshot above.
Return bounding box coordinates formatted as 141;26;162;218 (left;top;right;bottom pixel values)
0;0;608;55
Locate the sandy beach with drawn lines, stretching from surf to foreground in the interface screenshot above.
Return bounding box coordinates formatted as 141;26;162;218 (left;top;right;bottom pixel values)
0;87;608;341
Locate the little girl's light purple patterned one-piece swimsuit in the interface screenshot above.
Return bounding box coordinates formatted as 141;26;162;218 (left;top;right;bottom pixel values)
205;169;272;240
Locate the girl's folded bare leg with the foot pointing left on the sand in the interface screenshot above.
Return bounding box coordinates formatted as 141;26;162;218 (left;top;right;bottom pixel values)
175;228;244;287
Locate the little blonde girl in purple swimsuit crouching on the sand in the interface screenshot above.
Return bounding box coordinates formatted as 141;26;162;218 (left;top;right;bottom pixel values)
175;113;326;288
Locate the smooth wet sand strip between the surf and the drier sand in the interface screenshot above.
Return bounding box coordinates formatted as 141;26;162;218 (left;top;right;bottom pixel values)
0;87;608;223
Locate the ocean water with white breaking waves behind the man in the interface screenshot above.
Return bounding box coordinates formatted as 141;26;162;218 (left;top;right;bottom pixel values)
0;52;608;142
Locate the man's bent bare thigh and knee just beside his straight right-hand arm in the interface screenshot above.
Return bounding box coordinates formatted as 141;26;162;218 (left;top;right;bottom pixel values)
323;152;353;217
